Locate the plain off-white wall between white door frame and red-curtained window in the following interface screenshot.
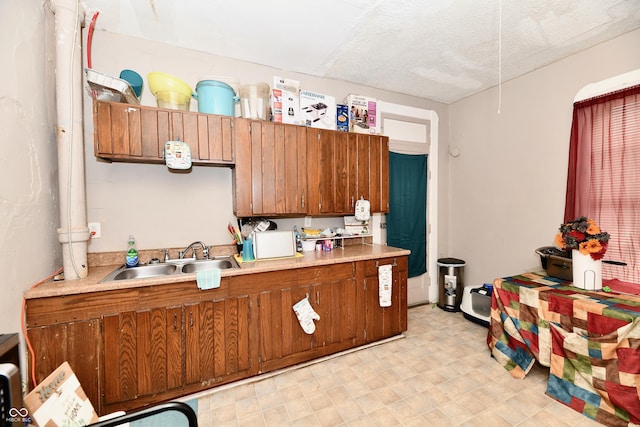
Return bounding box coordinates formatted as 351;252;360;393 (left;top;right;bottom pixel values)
448;30;640;285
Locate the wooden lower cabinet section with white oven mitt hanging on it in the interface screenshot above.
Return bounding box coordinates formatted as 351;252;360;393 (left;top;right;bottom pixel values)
238;263;359;371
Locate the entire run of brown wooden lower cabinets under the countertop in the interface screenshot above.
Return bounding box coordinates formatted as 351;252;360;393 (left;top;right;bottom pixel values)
26;256;407;415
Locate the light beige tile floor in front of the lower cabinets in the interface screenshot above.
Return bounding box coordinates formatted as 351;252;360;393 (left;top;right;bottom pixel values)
192;305;600;427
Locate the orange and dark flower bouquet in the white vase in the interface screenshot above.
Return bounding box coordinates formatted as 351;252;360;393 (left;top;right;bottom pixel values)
555;217;610;261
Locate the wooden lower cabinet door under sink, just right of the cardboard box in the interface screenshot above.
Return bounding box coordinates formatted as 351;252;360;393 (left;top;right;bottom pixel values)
103;307;182;405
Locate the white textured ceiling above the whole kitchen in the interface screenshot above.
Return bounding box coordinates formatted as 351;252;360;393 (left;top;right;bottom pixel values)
84;0;640;103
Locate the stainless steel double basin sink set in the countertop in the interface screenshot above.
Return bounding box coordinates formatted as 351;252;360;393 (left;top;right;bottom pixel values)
100;256;239;283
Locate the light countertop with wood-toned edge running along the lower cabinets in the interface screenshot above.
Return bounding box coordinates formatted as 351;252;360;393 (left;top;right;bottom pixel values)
24;244;410;299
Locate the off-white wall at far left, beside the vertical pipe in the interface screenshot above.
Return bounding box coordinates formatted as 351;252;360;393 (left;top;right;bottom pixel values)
0;0;62;350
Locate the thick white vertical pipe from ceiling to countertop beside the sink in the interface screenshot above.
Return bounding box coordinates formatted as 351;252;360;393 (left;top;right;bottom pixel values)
51;0;89;280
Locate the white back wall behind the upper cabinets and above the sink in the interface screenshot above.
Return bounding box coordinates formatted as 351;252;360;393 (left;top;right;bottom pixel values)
84;31;446;252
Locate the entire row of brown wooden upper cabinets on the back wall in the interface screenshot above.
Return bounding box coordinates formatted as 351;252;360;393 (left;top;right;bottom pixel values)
93;101;389;217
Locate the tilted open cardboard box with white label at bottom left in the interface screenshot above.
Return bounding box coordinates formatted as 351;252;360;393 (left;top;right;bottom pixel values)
24;362;98;427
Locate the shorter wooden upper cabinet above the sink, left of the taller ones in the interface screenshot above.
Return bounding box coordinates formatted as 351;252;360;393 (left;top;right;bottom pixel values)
93;101;234;165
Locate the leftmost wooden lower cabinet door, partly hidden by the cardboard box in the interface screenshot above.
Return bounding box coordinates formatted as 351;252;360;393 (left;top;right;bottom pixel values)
27;319;101;411
